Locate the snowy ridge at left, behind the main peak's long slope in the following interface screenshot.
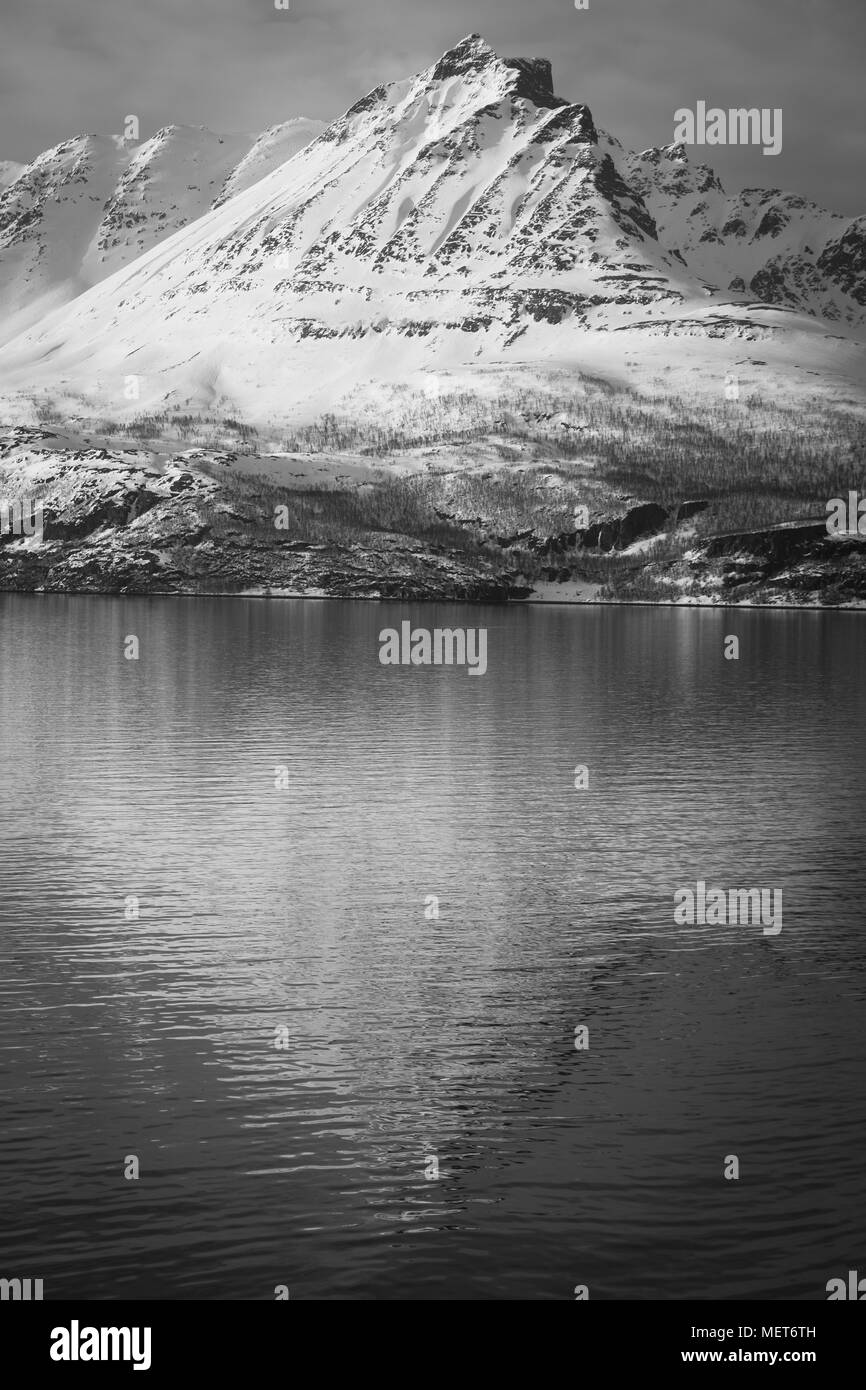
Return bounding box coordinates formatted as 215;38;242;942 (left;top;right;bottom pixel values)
0;120;322;341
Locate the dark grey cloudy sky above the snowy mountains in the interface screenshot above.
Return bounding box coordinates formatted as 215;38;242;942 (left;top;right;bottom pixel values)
0;0;866;214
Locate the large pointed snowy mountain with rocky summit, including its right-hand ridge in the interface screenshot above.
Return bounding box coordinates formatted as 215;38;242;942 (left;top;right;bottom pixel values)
0;35;866;418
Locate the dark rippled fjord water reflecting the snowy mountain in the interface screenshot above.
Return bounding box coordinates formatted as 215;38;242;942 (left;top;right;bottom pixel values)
0;595;866;1300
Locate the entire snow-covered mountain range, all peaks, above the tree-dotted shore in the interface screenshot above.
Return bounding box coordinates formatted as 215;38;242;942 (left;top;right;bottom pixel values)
0;25;866;420
